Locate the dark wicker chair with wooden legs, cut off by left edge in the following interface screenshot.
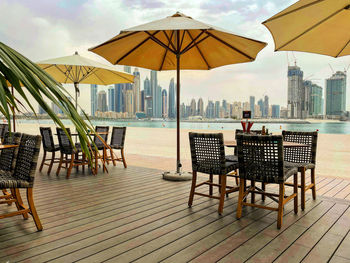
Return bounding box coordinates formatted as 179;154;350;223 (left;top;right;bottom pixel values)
0;134;43;231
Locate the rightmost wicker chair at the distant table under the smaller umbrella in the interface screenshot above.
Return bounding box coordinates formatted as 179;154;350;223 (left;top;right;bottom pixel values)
107;127;128;168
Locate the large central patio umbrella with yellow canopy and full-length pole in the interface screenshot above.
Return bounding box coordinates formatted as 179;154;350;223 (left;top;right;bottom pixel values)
89;12;266;180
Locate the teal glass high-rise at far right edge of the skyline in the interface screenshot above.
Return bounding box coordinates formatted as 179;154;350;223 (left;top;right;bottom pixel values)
326;71;346;116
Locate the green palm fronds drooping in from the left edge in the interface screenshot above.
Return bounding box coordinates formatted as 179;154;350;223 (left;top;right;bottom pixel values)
0;42;94;160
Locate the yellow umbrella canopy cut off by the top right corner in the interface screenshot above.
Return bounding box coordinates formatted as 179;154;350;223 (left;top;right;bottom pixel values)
263;0;350;57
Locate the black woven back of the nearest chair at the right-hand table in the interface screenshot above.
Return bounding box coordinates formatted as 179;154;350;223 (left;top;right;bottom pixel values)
237;134;284;183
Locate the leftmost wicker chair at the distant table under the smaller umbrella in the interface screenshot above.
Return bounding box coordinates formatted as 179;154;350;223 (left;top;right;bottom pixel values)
39;127;60;174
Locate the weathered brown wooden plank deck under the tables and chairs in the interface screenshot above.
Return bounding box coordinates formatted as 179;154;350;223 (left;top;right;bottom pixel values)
0;168;350;262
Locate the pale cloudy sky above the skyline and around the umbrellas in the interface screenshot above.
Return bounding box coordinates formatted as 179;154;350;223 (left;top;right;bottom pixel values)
0;0;350;113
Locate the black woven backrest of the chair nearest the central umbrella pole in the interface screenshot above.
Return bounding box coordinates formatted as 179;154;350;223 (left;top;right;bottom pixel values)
189;132;226;174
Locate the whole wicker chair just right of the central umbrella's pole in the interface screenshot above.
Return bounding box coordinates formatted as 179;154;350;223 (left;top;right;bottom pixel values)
188;132;238;214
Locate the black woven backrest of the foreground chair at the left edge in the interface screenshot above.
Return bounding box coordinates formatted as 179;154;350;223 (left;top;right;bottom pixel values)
13;133;41;187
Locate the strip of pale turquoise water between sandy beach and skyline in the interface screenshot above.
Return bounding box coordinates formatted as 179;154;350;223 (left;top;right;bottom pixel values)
18;120;350;134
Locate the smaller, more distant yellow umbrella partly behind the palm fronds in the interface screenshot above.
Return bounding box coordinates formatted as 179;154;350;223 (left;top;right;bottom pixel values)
37;52;134;107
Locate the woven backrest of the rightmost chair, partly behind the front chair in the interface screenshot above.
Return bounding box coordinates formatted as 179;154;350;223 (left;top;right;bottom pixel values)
282;131;318;164
